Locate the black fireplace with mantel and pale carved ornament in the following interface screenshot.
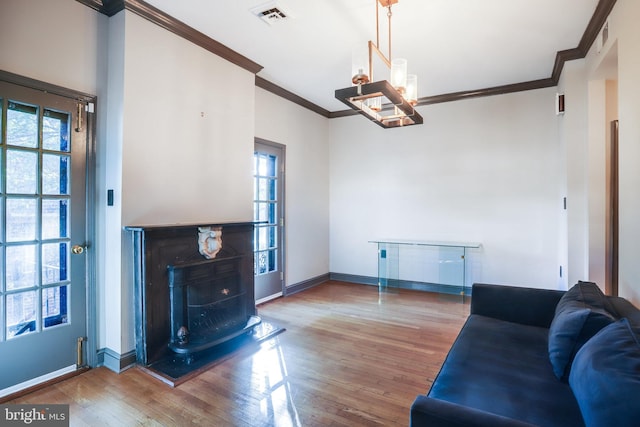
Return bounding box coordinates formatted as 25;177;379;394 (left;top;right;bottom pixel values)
125;222;261;366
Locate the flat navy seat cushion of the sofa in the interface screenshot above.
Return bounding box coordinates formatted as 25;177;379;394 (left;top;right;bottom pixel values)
428;314;584;427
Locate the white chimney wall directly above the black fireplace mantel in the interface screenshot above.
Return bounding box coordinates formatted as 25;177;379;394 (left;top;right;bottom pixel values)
122;12;254;225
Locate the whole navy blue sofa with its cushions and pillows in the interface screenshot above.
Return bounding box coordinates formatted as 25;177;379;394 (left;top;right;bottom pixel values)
411;282;640;427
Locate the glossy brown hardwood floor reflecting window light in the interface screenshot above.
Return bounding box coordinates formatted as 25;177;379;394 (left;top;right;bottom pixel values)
9;282;469;427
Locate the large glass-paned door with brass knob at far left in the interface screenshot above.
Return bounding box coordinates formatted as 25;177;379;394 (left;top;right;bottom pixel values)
0;81;87;394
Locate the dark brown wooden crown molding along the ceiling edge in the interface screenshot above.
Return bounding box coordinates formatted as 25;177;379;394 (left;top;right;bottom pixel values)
76;0;616;119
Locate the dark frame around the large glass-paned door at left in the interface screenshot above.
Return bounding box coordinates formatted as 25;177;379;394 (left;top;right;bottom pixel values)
0;70;98;367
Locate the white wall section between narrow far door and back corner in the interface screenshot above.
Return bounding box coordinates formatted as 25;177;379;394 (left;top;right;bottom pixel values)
255;87;329;286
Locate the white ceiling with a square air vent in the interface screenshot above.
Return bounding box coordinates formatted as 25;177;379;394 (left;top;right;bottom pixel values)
146;0;598;111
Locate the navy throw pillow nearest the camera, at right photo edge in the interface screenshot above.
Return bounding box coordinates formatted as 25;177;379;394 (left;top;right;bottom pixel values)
569;319;640;427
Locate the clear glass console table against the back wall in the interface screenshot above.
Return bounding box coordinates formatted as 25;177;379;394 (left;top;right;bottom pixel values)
369;239;481;301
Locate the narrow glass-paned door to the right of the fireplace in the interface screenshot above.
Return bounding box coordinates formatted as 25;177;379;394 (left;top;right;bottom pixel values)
253;140;284;303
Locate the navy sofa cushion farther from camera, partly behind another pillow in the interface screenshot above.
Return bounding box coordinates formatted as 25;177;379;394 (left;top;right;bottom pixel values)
549;282;615;381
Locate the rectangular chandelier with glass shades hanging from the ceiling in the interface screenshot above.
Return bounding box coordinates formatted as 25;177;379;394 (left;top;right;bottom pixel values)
335;0;422;129
